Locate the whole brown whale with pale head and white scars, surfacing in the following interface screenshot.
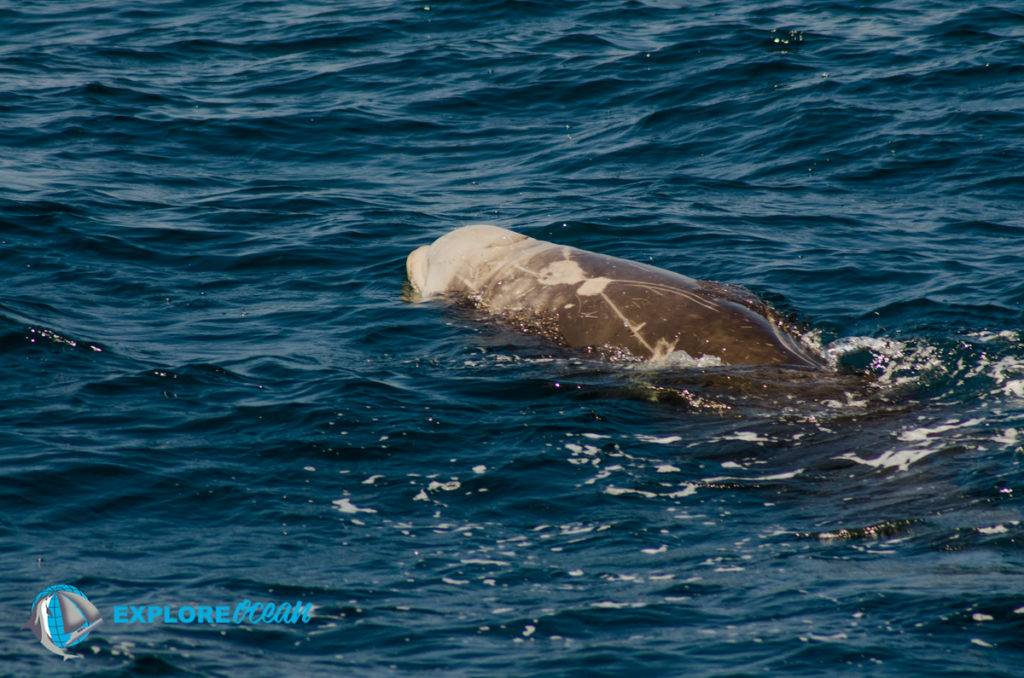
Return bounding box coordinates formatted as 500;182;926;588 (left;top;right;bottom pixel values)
406;224;826;370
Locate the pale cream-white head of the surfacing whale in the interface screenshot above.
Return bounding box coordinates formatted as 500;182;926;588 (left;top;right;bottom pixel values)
406;224;539;299
